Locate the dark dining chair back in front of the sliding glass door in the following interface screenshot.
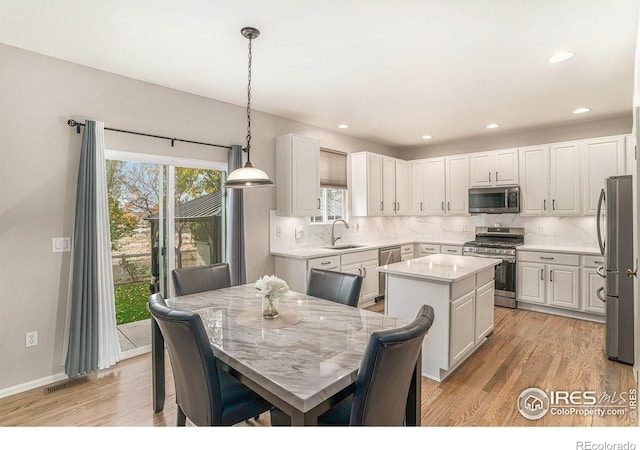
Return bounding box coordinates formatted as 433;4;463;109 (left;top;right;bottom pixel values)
171;263;231;296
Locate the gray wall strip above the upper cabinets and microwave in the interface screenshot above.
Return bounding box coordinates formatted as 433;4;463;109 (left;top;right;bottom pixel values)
399;111;633;160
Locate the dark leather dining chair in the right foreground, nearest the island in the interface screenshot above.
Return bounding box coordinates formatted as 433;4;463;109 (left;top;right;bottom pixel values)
271;305;434;426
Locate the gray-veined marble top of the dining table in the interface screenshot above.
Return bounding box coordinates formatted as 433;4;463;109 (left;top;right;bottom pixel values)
167;284;409;412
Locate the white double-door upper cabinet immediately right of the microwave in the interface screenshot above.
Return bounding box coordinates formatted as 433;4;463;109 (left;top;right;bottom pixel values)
519;142;581;216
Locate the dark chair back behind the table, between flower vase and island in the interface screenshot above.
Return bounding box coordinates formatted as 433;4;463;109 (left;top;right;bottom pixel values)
306;269;362;306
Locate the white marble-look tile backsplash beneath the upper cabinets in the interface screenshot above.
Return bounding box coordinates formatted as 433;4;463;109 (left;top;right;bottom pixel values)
269;210;598;252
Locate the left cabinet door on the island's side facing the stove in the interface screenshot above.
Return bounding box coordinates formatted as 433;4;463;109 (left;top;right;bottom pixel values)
449;291;476;366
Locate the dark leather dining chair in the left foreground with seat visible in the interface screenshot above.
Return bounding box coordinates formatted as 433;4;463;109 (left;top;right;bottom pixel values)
149;293;271;426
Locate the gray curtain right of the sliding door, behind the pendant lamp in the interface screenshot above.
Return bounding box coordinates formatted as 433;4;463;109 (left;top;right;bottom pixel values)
227;145;247;286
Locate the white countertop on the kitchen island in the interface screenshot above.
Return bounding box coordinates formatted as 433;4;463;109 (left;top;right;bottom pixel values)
376;254;502;282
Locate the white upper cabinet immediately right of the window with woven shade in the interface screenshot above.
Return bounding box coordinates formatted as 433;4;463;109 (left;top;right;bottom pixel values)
350;152;411;216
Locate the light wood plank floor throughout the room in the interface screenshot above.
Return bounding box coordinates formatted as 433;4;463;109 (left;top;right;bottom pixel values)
0;304;637;427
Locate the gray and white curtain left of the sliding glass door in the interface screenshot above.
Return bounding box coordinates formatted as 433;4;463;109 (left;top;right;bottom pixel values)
65;121;99;378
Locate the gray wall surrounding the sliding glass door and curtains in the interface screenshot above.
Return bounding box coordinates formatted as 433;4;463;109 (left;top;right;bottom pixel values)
0;44;397;394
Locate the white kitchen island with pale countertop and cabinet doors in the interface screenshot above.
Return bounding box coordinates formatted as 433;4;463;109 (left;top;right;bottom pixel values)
376;254;501;381
